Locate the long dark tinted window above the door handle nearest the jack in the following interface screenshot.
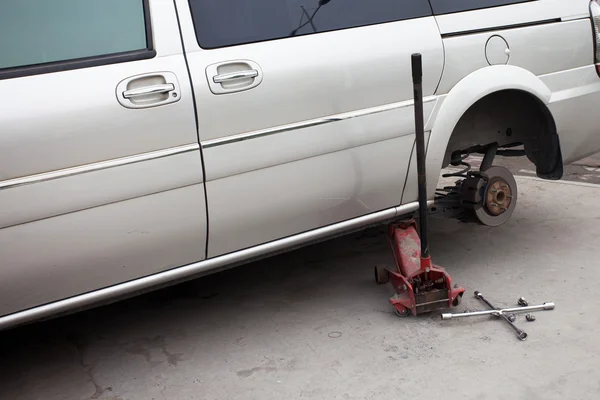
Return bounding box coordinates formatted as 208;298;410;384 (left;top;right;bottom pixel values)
189;0;431;48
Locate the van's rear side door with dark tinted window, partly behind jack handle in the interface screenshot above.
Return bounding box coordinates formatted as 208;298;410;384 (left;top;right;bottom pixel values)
176;0;443;256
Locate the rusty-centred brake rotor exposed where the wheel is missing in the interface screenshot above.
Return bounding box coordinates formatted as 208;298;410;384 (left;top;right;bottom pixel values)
474;166;517;226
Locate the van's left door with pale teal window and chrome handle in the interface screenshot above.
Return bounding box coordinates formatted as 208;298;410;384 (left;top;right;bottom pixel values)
0;0;206;315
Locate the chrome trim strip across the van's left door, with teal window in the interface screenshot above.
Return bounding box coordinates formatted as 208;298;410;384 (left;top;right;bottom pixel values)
0;143;200;190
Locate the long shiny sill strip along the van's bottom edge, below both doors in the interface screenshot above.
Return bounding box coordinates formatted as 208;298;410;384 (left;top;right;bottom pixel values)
0;201;424;329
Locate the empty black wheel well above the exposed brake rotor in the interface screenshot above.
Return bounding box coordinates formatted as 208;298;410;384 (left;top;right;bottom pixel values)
443;90;563;179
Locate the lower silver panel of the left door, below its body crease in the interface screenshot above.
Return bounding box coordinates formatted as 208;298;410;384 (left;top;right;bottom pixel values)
0;184;206;315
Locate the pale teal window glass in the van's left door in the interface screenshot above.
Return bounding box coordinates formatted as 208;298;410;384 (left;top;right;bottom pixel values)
0;0;147;69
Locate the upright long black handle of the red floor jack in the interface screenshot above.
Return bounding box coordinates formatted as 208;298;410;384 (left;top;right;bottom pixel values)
411;53;429;258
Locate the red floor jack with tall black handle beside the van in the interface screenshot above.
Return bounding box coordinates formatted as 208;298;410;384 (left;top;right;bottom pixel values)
375;54;465;317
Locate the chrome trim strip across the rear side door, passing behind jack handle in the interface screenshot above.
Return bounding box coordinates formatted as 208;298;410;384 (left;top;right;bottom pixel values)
201;96;437;149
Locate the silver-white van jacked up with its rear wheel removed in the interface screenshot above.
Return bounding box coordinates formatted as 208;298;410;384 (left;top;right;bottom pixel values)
0;0;600;328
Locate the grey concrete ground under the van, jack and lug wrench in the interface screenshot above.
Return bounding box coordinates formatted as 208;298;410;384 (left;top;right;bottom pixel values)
0;171;600;400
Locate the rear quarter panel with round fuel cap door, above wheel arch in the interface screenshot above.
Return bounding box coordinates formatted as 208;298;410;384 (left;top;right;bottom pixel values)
436;0;600;173
